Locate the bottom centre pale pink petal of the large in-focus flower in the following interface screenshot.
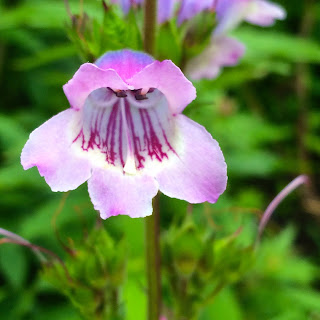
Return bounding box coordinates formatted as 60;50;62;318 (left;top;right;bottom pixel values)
88;169;158;219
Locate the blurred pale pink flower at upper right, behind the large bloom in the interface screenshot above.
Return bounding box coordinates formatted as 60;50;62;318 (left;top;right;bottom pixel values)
184;0;286;80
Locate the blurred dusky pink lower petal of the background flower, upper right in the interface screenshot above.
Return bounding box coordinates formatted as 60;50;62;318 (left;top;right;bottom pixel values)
185;37;245;80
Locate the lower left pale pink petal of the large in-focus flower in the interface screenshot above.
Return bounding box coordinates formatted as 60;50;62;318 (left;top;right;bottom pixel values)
21;109;91;191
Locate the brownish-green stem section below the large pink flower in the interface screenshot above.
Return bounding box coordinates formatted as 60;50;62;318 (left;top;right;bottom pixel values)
145;195;161;320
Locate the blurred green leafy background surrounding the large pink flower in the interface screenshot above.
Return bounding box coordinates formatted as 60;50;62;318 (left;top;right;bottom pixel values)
0;0;320;320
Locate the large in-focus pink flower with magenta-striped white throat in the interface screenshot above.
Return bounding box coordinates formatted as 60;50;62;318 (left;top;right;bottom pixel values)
21;50;227;219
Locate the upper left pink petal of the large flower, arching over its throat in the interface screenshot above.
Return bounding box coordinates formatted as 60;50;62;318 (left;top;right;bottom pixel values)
63;63;130;109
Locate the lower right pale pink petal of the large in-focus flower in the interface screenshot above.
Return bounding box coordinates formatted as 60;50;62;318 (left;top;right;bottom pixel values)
155;115;227;203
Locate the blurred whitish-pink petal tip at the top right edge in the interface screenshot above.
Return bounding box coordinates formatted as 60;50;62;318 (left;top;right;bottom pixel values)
245;0;286;27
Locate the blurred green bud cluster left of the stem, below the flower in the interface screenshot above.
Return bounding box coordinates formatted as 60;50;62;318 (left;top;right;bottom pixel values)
42;226;126;320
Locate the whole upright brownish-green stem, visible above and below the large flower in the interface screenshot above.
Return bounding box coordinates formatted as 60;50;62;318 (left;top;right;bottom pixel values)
143;0;161;320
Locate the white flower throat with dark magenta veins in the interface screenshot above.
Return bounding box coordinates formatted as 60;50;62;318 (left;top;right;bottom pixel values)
73;88;176;173
